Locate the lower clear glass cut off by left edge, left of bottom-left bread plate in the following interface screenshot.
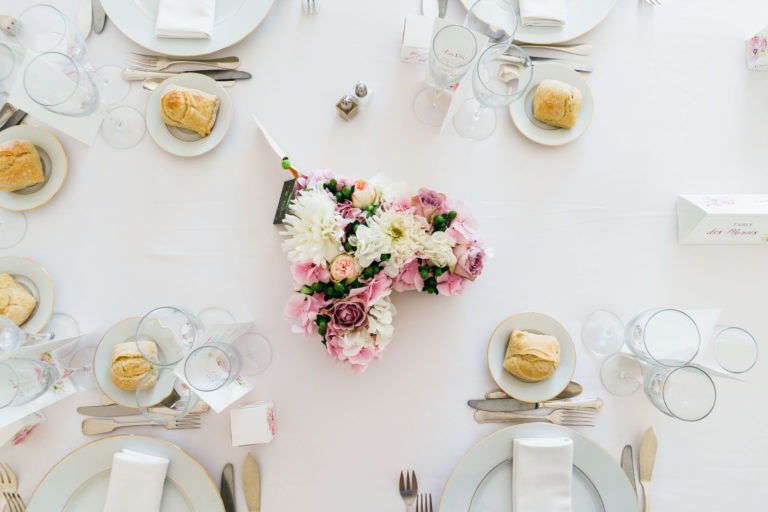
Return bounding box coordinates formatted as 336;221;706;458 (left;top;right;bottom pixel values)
0;358;58;409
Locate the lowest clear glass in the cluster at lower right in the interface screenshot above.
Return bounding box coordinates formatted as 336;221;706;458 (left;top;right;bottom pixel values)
643;366;717;421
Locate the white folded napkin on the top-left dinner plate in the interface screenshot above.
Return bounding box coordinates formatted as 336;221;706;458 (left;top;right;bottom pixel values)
155;0;216;39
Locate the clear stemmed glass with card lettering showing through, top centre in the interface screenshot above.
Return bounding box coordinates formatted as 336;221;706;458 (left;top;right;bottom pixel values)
413;25;477;126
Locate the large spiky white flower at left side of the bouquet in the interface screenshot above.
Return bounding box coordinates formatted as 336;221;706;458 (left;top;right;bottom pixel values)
280;189;344;265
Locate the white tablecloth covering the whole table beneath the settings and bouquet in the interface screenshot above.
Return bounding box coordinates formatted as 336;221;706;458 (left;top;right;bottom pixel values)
0;0;768;512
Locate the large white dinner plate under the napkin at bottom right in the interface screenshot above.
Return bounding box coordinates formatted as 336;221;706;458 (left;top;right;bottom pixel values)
438;423;638;512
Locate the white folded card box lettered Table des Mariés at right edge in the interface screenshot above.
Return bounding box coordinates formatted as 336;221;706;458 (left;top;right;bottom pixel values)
677;194;768;247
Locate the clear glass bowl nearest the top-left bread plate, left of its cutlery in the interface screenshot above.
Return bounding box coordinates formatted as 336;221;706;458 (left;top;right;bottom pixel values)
24;52;99;116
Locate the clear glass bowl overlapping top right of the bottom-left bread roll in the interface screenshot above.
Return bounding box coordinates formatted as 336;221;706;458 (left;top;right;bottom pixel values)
136;306;203;366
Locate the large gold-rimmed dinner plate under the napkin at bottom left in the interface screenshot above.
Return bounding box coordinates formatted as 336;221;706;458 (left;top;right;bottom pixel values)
27;435;224;512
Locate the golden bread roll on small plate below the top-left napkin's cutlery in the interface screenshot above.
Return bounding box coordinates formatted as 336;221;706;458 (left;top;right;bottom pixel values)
160;85;219;137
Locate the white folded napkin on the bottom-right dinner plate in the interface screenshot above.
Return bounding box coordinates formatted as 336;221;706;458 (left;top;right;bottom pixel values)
512;437;573;512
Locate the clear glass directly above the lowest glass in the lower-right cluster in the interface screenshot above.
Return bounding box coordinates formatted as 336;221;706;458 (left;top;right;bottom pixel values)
624;309;701;367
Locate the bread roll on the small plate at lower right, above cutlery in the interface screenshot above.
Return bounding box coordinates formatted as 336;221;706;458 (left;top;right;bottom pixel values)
504;330;560;382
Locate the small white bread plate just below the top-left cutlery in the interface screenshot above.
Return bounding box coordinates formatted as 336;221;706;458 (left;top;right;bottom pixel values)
144;73;232;157
